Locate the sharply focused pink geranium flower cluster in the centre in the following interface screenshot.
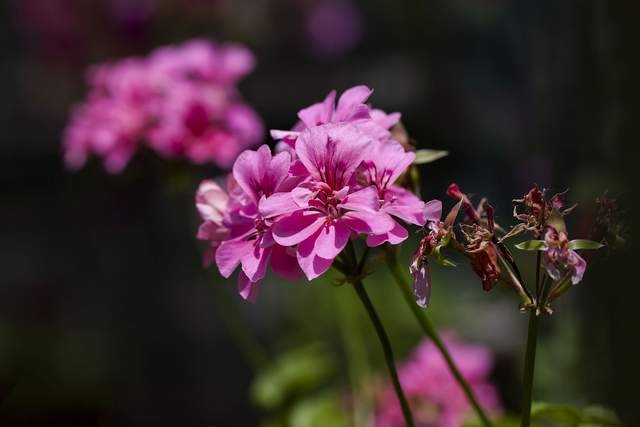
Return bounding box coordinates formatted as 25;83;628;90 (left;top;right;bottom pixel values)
196;86;436;299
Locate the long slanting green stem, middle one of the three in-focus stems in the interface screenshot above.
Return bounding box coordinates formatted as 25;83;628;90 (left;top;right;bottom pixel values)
387;247;492;427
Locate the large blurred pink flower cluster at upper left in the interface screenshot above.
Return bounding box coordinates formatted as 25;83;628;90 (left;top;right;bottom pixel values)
63;40;264;173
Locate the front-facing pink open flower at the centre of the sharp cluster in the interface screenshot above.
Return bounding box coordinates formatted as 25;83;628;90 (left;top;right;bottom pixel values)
274;124;394;280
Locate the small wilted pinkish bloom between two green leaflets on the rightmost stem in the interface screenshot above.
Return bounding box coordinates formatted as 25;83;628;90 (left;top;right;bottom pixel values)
542;227;587;285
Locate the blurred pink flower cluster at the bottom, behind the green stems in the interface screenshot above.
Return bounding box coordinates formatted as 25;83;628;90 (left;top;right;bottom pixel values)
374;336;501;427
